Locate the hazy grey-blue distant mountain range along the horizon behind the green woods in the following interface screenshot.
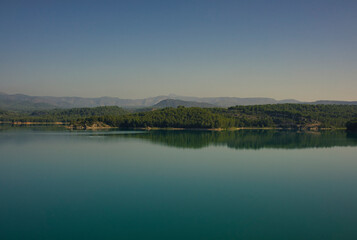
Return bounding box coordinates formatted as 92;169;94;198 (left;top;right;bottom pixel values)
0;93;357;111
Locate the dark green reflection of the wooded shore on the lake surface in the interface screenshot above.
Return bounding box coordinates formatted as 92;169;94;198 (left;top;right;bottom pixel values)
121;130;357;149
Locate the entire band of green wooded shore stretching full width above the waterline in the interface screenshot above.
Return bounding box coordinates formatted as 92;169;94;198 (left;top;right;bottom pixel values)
0;104;357;129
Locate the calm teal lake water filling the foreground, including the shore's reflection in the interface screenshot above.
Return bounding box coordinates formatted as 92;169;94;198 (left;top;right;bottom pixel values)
0;128;357;240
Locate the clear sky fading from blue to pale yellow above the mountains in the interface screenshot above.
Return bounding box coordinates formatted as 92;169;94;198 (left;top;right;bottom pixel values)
0;0;357;100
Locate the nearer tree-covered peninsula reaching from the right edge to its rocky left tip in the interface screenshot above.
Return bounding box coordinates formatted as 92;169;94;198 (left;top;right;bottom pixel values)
71;104;357;129
